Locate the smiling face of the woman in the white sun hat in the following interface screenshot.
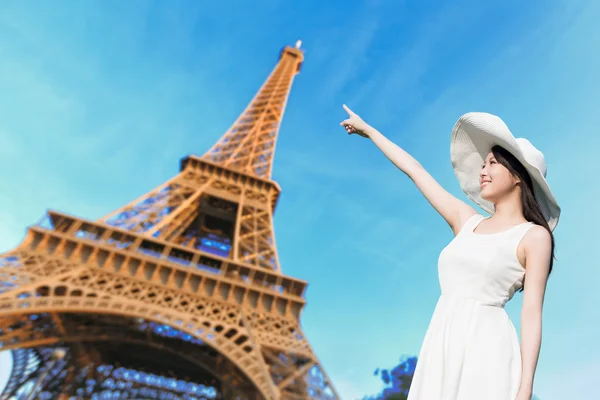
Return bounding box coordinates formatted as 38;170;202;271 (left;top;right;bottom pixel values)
479;152;519;203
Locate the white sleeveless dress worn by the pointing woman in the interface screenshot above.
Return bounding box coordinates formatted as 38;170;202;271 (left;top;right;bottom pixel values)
408;214;534;400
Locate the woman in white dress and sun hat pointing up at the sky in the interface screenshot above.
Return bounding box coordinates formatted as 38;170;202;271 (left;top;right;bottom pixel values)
341;105;560;400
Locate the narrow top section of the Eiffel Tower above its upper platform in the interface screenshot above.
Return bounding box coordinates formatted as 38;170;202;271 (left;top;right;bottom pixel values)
202;40;304;179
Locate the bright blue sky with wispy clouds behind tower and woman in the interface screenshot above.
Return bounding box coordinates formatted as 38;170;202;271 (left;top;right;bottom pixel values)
0;0;600;400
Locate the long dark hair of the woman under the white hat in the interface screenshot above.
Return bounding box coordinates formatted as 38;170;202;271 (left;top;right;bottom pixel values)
492;146;554;291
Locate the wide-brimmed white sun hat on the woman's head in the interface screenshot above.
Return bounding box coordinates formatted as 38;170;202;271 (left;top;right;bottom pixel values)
450;112;560;230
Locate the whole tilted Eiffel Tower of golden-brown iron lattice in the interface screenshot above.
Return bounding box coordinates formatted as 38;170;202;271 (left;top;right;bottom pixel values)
0;42;339;400
